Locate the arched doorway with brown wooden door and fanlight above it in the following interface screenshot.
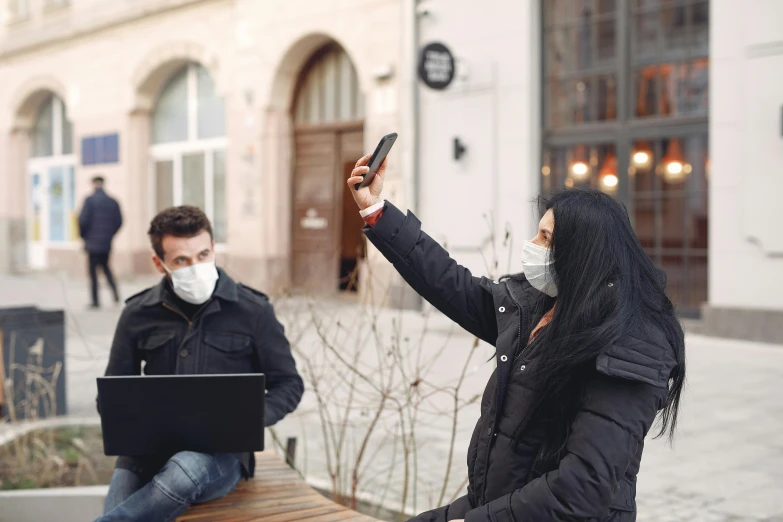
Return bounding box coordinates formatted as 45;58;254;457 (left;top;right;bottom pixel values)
292;43;365;293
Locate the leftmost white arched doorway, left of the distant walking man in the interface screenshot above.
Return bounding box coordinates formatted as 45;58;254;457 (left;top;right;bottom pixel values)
26;93;79;269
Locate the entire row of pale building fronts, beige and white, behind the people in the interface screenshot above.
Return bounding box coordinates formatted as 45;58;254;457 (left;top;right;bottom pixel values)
0;0;783;341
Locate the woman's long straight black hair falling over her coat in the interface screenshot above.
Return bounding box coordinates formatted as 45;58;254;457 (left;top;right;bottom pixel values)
520;189;685;466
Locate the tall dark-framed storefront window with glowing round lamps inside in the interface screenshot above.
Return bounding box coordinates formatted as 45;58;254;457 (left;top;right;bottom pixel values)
541;0;709;312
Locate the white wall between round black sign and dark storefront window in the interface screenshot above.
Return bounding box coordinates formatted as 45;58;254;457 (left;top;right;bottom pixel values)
419;0;540;275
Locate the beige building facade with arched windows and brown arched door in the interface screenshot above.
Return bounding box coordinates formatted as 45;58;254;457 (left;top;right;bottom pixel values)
0;0;404;292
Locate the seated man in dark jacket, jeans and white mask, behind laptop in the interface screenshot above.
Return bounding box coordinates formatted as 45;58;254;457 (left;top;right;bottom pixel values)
98;206;304;522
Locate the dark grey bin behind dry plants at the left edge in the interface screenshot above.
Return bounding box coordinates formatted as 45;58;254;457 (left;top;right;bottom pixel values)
0;306;67;421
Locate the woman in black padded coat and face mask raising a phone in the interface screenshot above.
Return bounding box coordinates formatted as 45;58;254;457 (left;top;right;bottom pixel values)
348;155;685;522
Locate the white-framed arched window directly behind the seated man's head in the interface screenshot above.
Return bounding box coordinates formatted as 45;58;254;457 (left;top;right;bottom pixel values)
150;63;227;243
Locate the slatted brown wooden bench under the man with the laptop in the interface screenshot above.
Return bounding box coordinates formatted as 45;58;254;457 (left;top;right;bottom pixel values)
177;452;386;522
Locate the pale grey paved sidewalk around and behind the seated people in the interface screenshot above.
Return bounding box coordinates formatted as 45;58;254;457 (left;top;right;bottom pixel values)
0;276;783;522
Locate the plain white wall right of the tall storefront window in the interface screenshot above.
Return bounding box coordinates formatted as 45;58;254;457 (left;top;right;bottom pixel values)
709;0;783;311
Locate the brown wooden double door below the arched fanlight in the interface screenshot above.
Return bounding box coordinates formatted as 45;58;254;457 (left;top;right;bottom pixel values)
292;123;365;295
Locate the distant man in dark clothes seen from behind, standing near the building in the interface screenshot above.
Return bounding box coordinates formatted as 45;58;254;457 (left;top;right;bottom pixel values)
79;176;122;308
